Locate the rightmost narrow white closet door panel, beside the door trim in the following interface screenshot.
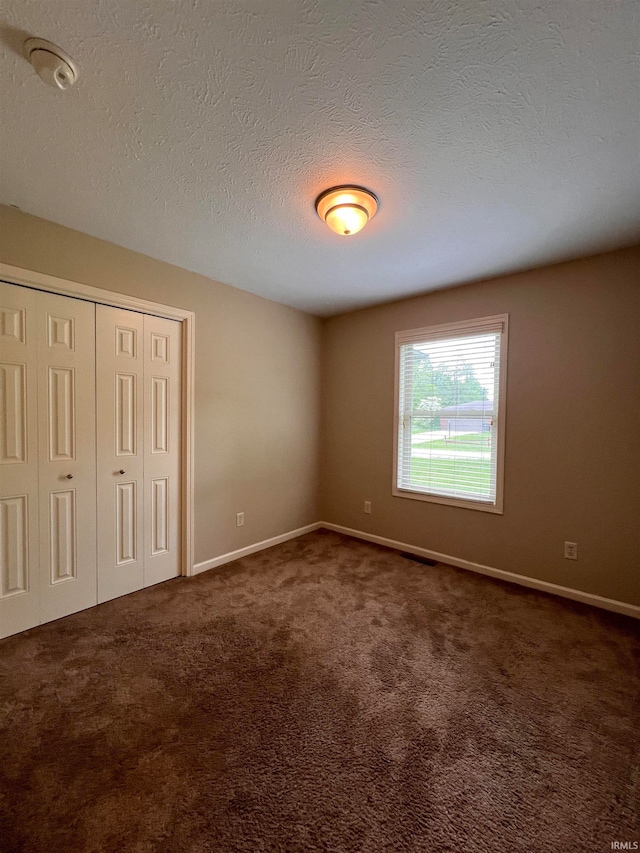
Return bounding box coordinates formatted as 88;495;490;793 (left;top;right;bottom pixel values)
144;315;182;586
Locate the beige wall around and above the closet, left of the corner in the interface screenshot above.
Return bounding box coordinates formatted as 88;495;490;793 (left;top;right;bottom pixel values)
0;207;321;562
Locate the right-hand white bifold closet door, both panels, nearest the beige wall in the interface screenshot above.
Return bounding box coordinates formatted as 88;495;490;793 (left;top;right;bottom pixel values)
96;305;181;602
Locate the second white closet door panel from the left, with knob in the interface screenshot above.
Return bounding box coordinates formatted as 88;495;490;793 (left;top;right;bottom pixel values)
37;292;97;622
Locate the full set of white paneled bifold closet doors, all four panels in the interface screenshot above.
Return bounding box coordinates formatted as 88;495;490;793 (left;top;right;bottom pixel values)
0;282;181;637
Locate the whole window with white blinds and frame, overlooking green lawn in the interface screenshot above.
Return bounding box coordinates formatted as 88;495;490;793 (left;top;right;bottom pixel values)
393;314;508;513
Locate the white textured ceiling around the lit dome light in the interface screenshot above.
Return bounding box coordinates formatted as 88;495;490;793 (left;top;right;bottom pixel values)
0;0;640;314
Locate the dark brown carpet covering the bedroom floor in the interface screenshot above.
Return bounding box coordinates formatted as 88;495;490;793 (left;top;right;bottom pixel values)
0;531;640;853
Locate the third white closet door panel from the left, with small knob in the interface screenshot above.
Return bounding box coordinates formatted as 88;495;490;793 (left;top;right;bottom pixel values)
96;305;144;602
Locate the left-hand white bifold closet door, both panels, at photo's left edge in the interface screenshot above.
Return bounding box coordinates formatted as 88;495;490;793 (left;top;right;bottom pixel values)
0;282;96;636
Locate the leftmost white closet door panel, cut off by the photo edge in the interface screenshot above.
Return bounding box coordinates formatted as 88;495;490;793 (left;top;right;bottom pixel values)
0;282;40;638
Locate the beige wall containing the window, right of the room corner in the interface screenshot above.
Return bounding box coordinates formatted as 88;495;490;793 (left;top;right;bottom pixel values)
320;248;640;604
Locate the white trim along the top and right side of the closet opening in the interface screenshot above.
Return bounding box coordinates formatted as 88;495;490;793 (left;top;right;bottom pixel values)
0;263;195;577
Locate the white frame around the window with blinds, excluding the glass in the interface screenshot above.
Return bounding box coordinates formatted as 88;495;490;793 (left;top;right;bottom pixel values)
391;314;509;515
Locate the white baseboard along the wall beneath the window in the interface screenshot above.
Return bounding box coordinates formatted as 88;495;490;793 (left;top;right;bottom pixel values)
315;521;640;619
